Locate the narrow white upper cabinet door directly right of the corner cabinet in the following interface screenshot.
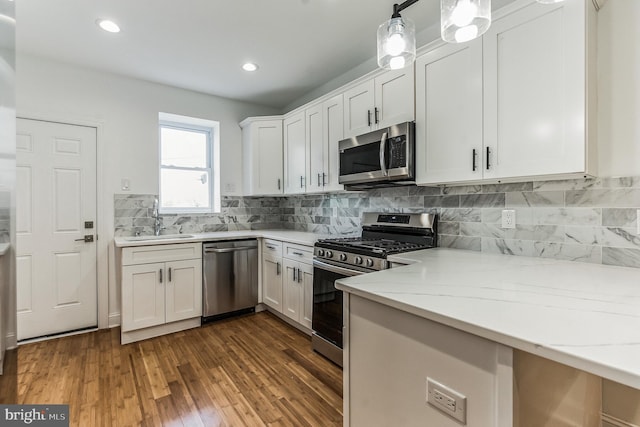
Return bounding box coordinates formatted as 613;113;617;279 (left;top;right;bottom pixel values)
283;112;307;194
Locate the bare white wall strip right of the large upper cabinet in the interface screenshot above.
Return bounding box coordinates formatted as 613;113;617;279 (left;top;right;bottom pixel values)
598;0;640;176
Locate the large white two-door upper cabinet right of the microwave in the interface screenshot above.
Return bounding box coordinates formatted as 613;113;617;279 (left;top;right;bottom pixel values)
416;0;596;184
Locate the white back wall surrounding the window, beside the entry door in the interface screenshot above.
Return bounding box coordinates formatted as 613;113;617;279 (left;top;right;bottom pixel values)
16;53;278;325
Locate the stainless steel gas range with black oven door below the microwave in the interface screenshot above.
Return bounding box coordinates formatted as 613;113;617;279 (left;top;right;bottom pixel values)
311;212;438;366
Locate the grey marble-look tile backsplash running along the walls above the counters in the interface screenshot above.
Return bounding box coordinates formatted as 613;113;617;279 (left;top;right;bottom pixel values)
115;177;640;267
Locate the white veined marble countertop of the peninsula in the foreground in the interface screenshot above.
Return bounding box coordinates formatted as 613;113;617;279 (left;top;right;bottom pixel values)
336;248;640;389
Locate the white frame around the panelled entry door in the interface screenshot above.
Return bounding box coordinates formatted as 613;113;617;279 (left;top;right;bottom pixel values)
16;111;113;337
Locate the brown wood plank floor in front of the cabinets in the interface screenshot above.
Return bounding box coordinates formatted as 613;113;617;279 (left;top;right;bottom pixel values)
12;312;342;427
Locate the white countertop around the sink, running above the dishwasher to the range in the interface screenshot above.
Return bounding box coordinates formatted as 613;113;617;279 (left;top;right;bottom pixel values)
114;230;331;248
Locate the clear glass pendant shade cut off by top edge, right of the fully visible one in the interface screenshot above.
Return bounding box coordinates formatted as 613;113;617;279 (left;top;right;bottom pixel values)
440;0;492;43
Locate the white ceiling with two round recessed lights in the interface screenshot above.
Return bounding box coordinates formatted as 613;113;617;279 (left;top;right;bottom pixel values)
16;0;512;108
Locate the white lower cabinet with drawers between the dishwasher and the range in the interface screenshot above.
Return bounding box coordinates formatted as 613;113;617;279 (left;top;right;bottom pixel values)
262;239;313;329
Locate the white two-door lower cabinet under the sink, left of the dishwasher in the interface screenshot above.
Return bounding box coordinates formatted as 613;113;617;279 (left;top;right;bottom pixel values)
121;243;202;344
